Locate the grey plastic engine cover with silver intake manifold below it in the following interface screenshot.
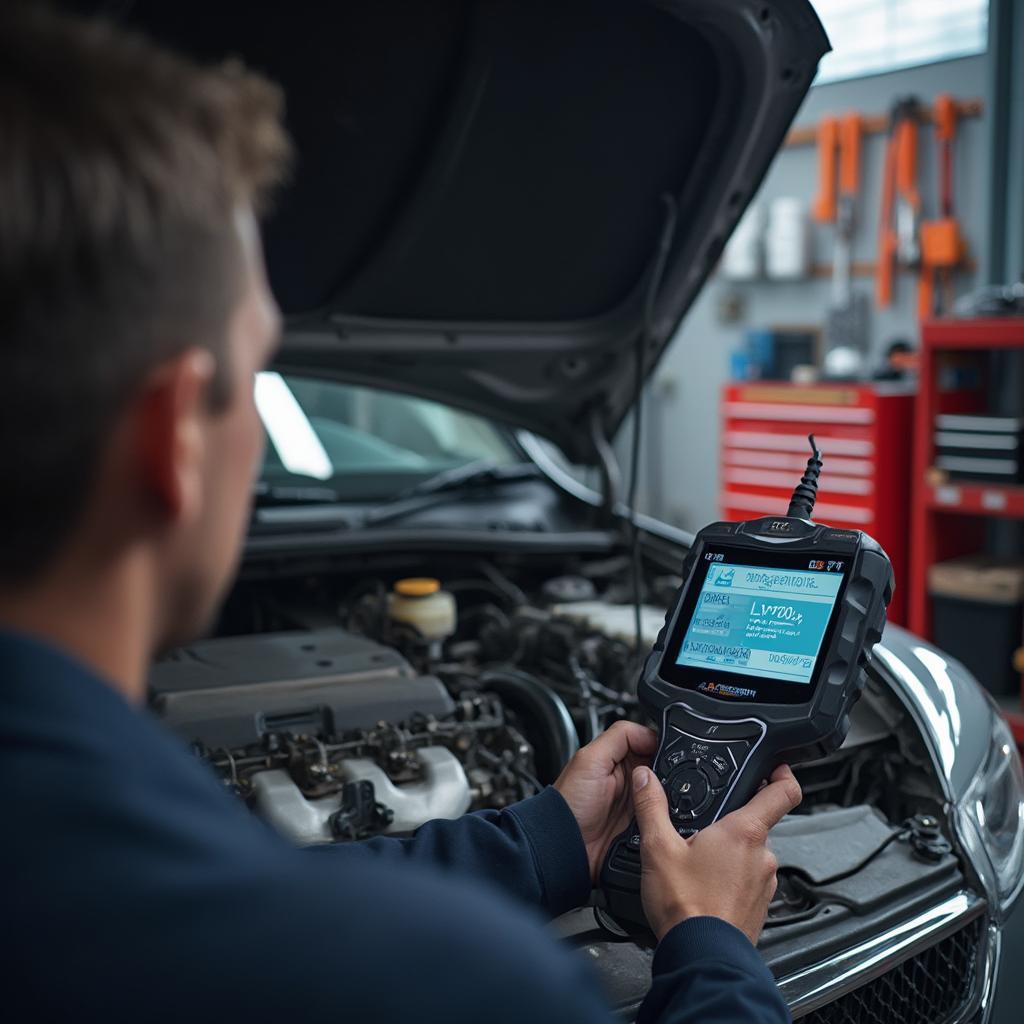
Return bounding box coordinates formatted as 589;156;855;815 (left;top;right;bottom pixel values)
151;629;540;843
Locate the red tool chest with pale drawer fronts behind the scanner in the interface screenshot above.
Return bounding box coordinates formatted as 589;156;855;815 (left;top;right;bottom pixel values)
720;383;913;624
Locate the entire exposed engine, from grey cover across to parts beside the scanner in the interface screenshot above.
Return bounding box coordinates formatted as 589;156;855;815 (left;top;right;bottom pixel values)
150;570;664;843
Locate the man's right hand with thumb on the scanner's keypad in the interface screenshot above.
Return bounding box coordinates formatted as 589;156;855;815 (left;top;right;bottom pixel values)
630;752;802;942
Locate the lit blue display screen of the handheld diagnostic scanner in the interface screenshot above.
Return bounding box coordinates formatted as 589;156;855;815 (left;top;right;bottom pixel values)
676;556;843;684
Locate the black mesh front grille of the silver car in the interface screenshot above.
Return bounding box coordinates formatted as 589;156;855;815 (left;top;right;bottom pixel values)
800;918;985;1024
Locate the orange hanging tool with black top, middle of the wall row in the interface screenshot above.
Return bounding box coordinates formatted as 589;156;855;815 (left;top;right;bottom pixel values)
874;96;921;308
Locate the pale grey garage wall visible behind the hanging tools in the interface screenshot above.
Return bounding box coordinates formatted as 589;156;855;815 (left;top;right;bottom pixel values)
638;55;990;529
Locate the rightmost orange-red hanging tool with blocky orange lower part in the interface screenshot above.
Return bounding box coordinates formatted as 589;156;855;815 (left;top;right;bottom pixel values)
918;95;965;319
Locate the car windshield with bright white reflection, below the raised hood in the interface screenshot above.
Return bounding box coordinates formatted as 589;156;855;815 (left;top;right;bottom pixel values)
256;371;523;501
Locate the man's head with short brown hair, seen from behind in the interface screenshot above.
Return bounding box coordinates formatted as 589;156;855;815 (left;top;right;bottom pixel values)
0;9;289;643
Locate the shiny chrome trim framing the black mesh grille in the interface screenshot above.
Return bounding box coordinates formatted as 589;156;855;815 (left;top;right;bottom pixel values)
778;891;998;1024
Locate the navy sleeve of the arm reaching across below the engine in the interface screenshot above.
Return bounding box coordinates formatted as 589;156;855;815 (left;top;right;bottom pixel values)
309;786;591;916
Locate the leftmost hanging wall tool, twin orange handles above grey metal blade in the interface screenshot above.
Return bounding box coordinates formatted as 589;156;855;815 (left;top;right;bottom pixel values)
814;114;867;377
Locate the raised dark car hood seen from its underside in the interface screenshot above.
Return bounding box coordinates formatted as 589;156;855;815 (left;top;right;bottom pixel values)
99;0;828;461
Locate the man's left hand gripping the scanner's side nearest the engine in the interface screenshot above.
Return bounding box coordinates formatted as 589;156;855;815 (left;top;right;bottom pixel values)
555;722;657;885
